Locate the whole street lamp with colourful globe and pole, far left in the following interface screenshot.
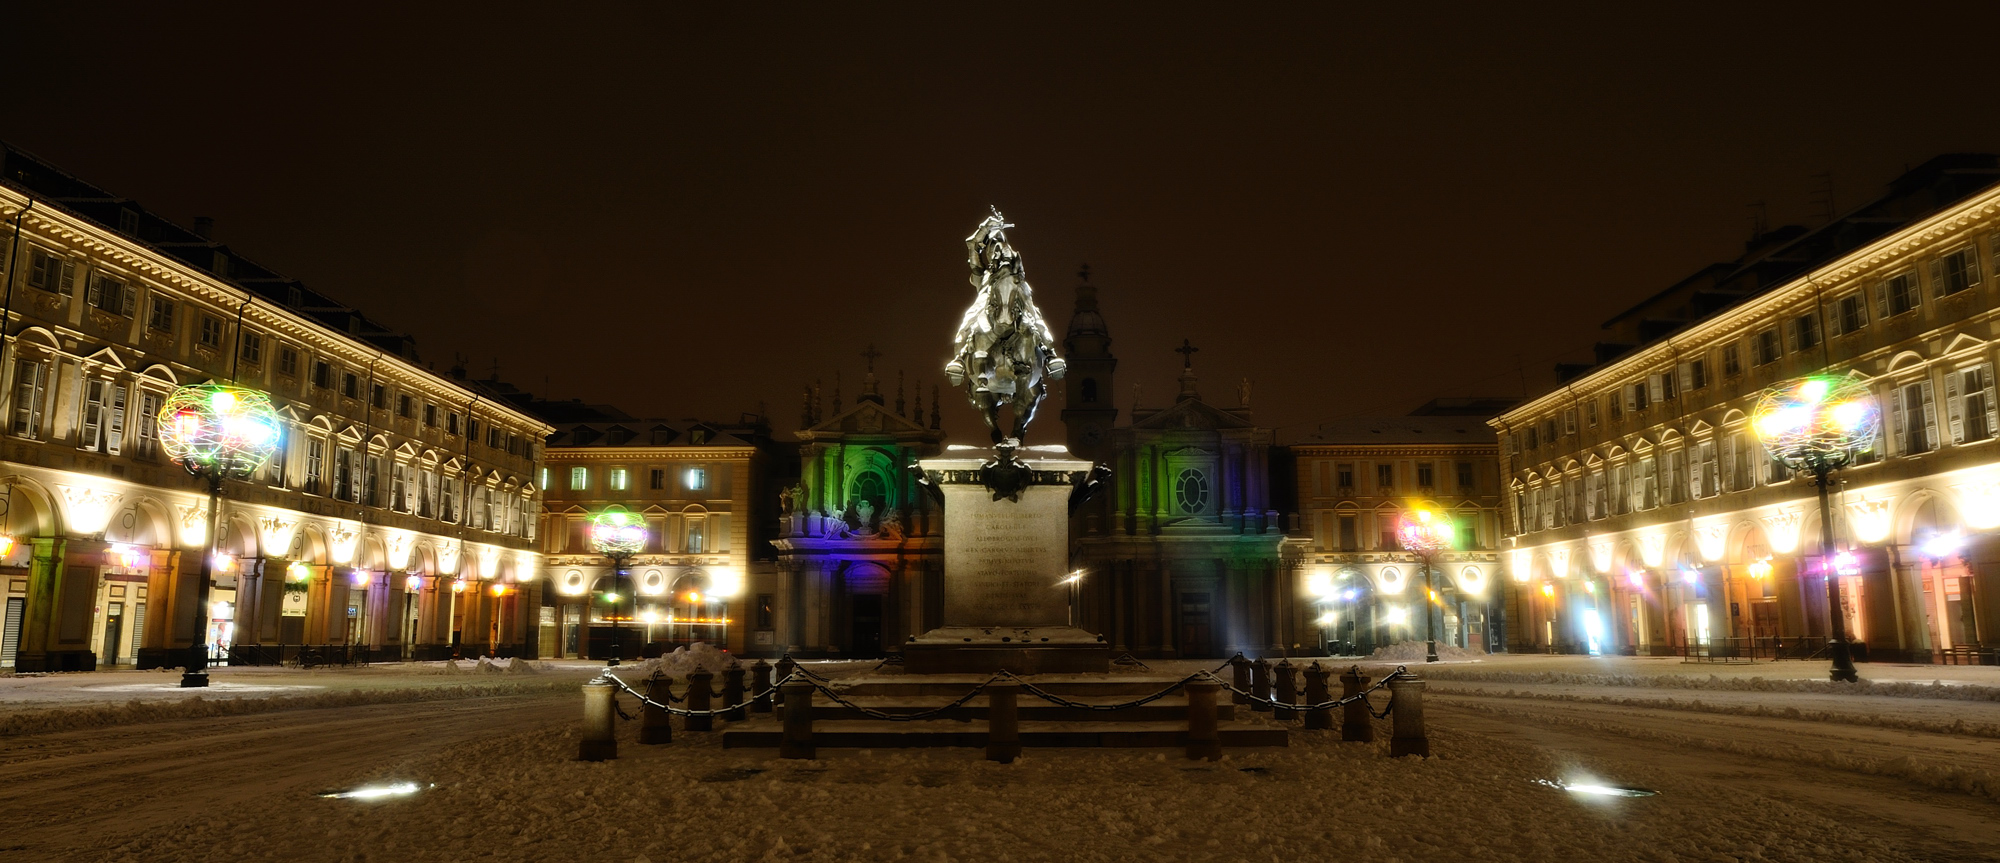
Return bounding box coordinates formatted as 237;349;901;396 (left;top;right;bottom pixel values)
158;384;278;689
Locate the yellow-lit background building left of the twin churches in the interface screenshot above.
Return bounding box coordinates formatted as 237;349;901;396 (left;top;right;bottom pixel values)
536;402;790;659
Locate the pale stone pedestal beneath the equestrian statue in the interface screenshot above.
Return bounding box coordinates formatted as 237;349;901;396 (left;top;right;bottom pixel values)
904;447;1110;673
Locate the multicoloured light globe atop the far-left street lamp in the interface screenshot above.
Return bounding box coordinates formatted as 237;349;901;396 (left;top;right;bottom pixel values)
160;384;280;475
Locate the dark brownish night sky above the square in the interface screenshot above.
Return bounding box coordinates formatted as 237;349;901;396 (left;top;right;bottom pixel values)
0;4;2000;441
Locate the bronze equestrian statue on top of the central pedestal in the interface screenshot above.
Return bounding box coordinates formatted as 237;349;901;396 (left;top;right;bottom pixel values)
944;210;1066;449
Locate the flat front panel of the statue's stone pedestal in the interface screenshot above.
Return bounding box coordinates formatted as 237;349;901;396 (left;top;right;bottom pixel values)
944;485;1070;627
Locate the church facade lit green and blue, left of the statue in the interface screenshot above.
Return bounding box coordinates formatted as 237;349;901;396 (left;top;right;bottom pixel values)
776;367;944;657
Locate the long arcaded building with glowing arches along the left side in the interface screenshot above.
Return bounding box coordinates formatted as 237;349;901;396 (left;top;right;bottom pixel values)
0;144;550;671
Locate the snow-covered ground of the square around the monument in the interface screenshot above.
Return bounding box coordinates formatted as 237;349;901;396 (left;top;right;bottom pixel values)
11;657;2000;863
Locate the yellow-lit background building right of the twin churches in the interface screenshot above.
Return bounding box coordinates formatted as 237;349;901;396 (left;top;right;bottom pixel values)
1290;411;1506;653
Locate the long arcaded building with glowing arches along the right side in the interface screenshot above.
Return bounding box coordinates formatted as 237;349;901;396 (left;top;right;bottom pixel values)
1492;156;2000;661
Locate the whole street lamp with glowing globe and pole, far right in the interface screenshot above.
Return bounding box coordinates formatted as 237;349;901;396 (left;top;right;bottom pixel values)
1750;376;1882;683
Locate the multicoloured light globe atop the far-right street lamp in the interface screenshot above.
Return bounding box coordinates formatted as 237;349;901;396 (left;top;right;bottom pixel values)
1750;376;1882;469
